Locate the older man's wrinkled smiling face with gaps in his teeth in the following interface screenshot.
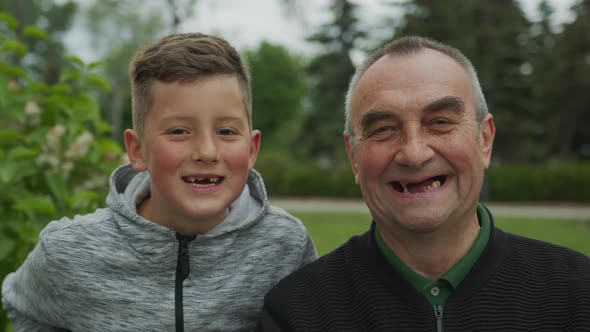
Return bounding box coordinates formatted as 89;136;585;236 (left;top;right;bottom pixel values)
345;49;495;233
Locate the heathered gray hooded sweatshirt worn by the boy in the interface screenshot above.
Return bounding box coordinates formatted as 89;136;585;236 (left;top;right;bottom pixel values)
2;165;317;332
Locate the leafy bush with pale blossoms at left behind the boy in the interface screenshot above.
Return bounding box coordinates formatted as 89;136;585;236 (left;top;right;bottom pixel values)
0;13;122;330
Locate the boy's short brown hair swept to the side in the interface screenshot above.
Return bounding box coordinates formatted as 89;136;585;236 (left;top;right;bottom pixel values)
129;33;252;137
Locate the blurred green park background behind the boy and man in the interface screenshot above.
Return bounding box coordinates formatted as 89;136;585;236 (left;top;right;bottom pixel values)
0;0;590;330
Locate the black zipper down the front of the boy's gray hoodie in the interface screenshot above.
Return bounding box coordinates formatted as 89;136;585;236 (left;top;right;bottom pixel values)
174;233;196;332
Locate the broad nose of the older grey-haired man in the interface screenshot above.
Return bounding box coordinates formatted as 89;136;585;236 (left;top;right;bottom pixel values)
394;128;435;168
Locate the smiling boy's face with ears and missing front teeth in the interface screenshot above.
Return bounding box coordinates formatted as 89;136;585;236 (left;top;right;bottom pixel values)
125;75;260;233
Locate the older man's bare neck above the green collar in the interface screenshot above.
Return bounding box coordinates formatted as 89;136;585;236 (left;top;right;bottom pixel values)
377;215;480;280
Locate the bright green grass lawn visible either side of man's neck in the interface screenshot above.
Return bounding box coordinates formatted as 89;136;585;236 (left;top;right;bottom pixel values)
291;211;590;256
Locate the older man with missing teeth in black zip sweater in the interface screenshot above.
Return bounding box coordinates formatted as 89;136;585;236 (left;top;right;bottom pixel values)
258;37;590;331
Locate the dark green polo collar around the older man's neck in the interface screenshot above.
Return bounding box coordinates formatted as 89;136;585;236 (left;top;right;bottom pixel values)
375;204;490;304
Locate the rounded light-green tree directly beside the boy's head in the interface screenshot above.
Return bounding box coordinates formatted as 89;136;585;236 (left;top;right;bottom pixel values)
245;42;307;149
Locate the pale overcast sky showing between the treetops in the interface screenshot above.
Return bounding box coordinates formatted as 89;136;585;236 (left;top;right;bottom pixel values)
66;0;575;61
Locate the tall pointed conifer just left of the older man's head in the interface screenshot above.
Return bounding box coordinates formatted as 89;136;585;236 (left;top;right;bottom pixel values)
299;0;366;166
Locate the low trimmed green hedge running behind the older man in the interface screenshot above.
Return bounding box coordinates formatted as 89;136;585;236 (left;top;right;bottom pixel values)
256;150;590;203
